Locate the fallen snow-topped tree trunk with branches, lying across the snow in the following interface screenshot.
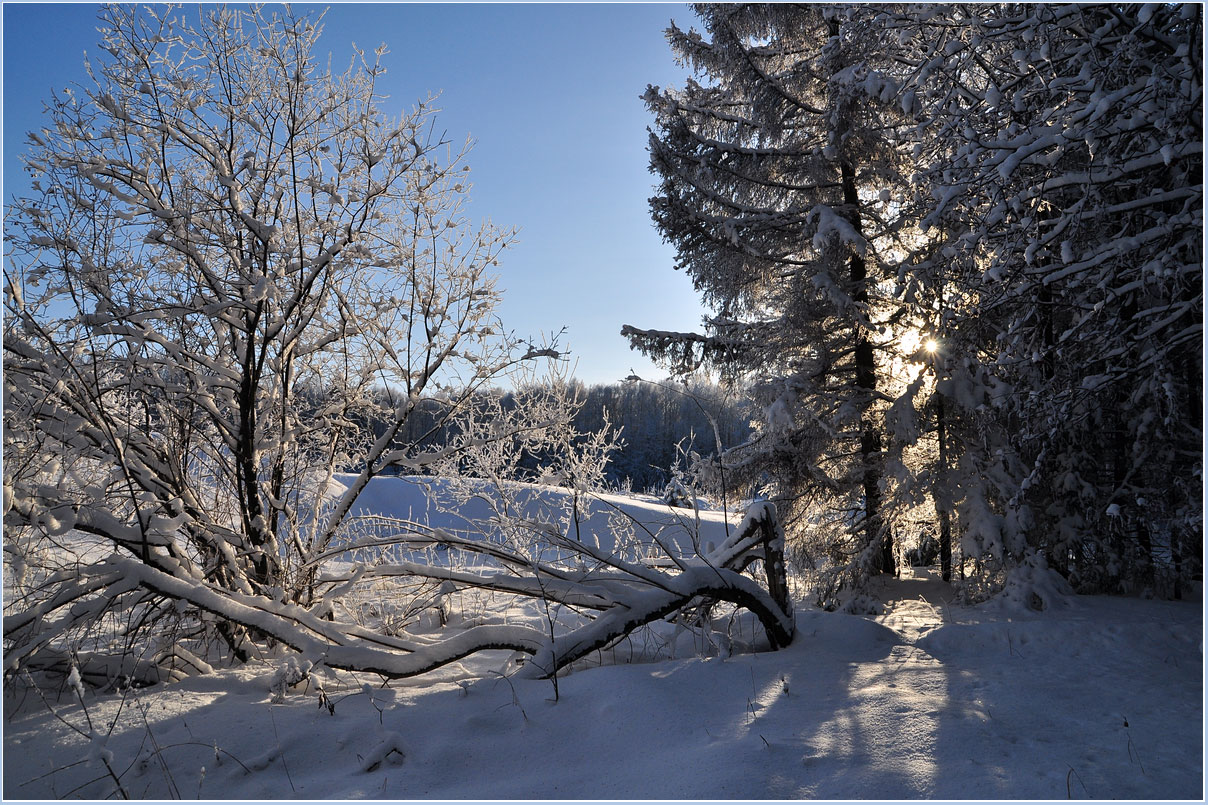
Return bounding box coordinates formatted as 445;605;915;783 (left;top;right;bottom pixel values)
5;503;795;678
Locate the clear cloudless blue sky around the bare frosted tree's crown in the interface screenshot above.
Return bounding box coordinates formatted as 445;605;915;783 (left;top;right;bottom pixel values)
4;4;703;383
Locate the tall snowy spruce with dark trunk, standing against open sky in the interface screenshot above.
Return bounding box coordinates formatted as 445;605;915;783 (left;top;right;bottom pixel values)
625;4;910;598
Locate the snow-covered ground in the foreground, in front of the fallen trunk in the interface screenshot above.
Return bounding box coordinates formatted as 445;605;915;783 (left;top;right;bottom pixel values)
4;479;1203;800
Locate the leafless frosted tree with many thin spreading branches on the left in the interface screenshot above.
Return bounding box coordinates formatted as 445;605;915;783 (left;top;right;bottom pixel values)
4;6;538;668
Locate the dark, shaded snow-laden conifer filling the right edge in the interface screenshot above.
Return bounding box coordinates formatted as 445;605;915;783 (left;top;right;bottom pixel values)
912;5;1203;596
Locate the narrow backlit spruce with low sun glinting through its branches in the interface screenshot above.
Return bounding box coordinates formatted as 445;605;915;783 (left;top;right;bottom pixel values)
877;5;1043;596
